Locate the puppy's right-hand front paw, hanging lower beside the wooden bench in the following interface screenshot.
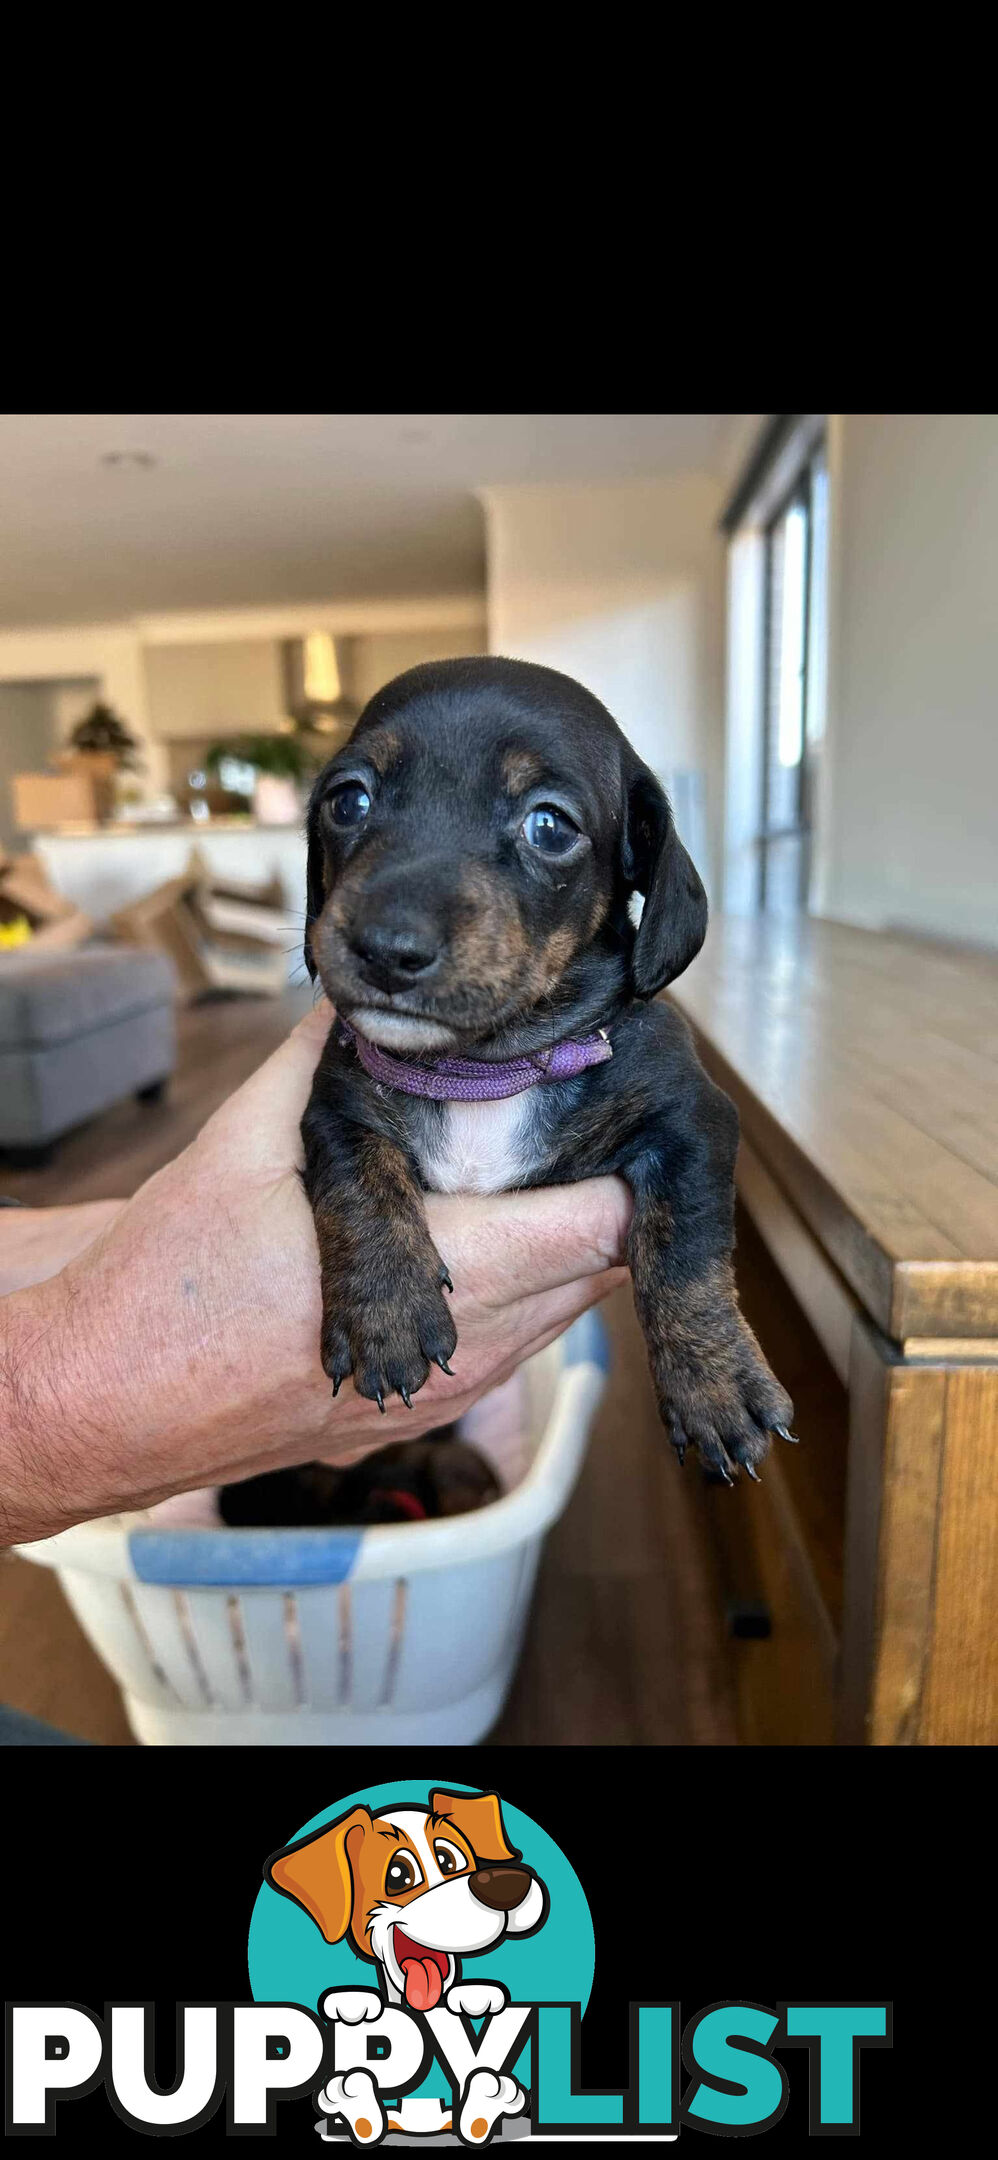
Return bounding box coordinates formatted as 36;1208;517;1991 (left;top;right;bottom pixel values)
652;1311;795;1484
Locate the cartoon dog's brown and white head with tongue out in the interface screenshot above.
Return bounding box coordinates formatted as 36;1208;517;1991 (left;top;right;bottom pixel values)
264;1793;547;2009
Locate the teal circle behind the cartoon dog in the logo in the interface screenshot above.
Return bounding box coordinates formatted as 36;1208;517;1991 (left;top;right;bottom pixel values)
248;1778;596;2093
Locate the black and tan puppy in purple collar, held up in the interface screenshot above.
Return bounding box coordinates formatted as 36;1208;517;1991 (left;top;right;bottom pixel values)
302;659;793;1480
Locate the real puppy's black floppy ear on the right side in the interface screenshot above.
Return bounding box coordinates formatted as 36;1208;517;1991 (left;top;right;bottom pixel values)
620;758;706;998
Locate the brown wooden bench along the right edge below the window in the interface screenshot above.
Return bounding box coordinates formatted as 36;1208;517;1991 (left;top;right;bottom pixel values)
670;918;998;1745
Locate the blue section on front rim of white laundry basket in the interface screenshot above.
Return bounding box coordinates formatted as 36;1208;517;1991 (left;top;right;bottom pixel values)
127;1529;363;1590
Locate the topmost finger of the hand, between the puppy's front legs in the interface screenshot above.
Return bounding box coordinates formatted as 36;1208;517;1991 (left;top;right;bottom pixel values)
428;1177;633;1305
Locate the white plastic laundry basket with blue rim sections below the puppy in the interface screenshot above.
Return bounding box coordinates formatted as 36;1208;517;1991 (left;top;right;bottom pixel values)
19;1313;609;1747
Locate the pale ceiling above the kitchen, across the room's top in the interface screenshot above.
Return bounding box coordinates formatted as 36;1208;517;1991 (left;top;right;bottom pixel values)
0;413;754;629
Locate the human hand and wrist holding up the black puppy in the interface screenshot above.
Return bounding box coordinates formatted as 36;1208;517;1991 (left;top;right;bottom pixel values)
0;1004;631;1542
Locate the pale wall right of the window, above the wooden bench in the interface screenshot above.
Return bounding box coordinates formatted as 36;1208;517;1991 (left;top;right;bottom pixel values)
819;413;998;942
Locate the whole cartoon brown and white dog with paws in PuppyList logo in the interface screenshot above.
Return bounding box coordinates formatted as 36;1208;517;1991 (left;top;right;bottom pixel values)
264;1793;549;2145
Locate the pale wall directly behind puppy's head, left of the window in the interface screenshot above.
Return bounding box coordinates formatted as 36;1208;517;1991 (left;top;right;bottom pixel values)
482;473;724;890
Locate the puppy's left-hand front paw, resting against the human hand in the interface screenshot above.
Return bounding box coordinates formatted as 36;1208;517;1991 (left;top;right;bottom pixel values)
322;1259;458;1410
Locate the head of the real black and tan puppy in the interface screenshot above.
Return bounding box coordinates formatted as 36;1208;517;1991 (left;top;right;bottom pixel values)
305;659;706;1052
